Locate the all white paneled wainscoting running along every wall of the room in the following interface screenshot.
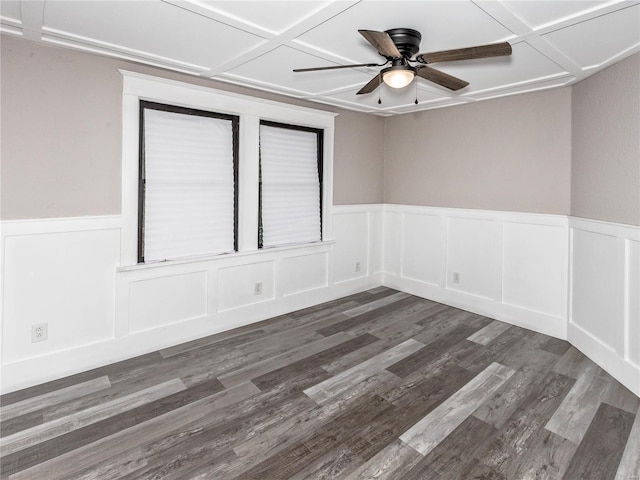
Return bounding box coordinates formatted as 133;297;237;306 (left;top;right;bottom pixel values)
0;205;640;395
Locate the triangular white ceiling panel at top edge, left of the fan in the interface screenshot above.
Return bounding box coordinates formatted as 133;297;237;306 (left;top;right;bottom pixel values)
199;0;331;34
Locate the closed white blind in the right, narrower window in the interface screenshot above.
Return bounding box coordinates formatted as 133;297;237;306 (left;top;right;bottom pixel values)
260;124;322;247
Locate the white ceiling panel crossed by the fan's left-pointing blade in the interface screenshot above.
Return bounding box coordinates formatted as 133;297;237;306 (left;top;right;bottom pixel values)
223;46;375;94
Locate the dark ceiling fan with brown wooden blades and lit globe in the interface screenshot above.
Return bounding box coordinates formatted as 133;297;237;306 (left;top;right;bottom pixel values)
293;28;511;95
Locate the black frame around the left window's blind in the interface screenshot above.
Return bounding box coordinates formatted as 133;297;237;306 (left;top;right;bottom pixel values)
138;100;240;263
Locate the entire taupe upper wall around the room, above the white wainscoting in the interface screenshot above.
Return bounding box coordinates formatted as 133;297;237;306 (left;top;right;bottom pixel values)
0;35;640;225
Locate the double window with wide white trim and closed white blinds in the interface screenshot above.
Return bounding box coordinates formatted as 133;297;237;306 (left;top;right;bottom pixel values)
120;70;336;269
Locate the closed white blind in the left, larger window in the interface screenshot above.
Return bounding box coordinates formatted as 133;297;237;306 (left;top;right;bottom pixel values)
142;108;235;262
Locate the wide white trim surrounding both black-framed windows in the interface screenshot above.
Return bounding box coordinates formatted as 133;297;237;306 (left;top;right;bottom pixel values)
120;70;337;267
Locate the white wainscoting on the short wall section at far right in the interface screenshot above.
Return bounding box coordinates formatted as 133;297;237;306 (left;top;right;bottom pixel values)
568;218;640;396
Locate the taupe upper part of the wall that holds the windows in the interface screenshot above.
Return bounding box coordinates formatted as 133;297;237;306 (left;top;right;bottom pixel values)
0;35;384;220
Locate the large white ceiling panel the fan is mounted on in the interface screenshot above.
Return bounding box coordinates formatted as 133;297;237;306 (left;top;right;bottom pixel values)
297;0;513;63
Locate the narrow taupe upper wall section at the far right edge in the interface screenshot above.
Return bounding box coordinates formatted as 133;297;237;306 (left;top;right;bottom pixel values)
571;54;640;225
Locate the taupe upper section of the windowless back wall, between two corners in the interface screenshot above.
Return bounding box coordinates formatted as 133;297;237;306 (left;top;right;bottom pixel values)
384;88;571;214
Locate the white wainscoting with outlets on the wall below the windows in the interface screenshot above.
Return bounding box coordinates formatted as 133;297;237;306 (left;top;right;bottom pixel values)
0;205;383;393
